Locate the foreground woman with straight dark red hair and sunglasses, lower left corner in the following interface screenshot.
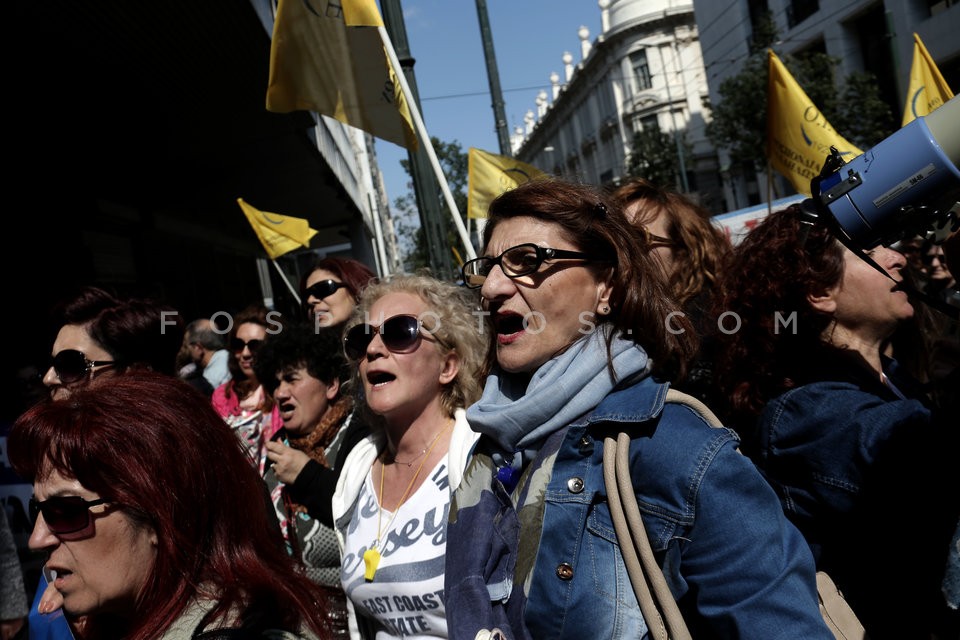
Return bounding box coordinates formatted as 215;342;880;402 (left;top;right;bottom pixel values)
9;371;328;640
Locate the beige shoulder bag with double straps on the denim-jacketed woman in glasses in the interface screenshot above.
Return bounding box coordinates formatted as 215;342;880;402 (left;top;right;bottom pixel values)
603;389;867;640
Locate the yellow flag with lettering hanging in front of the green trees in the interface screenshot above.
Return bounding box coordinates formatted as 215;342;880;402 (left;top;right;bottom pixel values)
767;49;863;196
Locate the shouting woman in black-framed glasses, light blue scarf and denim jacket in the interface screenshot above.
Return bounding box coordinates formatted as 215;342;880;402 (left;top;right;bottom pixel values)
445;181;832;640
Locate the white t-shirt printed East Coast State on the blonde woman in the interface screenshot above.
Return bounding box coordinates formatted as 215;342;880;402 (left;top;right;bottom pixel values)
340;457;450;638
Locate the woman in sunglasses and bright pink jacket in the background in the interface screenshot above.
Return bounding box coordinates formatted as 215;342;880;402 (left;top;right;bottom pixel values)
211;305;282;473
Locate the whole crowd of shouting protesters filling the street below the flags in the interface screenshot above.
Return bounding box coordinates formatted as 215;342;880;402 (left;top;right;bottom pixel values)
0;180;960;640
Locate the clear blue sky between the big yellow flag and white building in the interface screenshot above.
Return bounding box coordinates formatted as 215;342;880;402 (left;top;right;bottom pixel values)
376;0;600;213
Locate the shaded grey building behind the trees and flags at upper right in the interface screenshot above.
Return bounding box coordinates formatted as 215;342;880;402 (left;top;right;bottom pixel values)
694;0;960;209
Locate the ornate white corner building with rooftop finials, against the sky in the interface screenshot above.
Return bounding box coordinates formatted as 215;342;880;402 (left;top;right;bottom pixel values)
512;0;721;212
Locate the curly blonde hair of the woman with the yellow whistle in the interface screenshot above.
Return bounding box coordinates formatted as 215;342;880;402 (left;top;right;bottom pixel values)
343;274;490;416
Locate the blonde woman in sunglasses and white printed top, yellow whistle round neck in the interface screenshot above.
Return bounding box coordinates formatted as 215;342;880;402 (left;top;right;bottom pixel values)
333;276;488;638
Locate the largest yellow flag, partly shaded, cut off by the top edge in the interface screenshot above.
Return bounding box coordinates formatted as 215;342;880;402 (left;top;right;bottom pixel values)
267;0;417;149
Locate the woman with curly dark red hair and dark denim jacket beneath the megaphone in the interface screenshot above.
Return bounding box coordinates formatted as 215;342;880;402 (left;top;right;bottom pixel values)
719;206;960;640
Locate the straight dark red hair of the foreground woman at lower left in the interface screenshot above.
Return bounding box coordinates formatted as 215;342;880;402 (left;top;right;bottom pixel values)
9;371;329;640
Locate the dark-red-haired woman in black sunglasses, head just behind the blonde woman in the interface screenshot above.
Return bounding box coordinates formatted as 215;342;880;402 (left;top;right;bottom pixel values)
300;258;374;328
